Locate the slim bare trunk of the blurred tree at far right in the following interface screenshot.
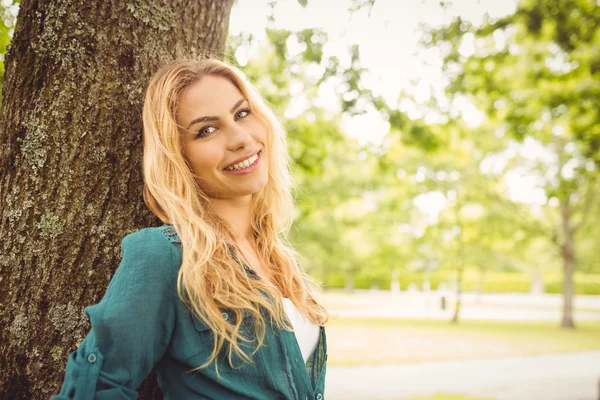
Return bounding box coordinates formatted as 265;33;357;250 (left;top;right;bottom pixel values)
560;201;575;328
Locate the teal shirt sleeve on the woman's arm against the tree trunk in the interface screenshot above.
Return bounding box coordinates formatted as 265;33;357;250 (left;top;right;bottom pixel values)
53;229;176;400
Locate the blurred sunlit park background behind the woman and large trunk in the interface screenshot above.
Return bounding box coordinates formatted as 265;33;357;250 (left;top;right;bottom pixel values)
0;0;600;400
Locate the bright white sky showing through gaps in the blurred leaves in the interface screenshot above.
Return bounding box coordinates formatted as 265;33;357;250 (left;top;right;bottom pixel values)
229;0;552;223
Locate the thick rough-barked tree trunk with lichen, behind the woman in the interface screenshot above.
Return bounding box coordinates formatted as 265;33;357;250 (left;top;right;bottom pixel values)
0;0;233;400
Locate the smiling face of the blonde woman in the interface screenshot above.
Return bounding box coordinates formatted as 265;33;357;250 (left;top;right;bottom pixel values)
176;75;268;199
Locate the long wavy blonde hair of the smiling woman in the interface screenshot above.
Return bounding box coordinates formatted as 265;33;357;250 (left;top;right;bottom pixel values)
143;59;328;368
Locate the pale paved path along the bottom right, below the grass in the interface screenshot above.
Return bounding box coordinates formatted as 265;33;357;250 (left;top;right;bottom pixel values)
325;352;600;400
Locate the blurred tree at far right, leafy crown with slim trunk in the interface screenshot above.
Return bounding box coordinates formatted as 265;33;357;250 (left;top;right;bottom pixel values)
424;0;600;328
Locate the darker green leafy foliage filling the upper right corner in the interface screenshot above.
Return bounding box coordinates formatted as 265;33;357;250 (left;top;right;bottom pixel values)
424;0;600;162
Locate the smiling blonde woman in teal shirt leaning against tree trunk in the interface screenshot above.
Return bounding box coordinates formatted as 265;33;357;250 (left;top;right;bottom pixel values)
54;60;327;400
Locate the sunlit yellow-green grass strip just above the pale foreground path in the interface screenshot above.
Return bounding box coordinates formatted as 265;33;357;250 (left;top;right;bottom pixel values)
327;317;600;365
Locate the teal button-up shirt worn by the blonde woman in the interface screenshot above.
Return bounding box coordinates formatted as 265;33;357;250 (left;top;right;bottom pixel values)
53;225;327;400
